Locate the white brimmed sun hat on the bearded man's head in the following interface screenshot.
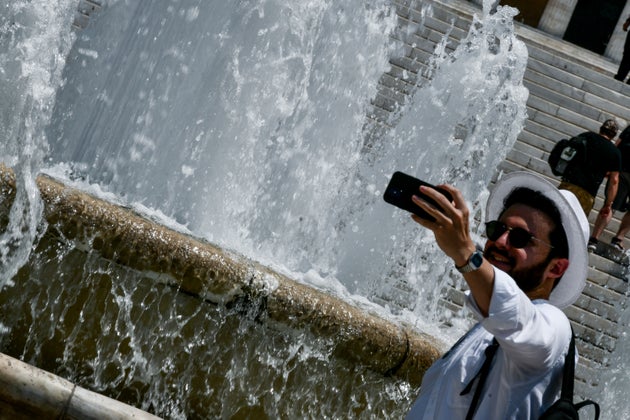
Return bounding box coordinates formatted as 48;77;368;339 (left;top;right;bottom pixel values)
486;171;590;309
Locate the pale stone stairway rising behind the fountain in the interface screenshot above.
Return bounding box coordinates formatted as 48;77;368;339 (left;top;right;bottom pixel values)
368;0;630;398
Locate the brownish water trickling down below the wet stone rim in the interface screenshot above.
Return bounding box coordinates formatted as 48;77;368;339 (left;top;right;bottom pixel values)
0;231;416;419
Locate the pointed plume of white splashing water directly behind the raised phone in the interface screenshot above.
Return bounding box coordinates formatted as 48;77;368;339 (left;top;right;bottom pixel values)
328;2;527;319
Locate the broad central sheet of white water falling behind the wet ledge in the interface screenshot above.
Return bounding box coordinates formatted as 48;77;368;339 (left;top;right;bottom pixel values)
45;1;395;286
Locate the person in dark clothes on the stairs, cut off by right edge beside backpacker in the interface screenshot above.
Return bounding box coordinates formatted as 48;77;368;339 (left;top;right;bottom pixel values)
588;125;630;251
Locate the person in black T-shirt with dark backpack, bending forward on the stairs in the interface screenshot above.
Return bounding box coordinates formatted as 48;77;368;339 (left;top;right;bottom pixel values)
558;119;621;217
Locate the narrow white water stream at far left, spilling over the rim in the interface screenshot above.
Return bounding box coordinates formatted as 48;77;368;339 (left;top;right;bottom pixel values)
0;1;72;289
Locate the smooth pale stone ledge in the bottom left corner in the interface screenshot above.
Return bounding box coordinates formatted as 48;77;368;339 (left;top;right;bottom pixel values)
0;354;159;420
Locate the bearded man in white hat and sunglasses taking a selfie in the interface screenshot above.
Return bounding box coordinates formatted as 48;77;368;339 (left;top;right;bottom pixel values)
407;172;589;420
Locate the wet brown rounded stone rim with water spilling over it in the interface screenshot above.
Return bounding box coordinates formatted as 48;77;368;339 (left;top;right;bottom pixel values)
0;162;441;398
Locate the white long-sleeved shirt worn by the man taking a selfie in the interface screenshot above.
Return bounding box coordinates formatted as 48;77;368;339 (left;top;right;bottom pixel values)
407;268;577;420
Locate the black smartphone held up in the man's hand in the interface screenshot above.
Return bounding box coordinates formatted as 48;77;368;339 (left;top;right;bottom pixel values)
383;172;453;221
